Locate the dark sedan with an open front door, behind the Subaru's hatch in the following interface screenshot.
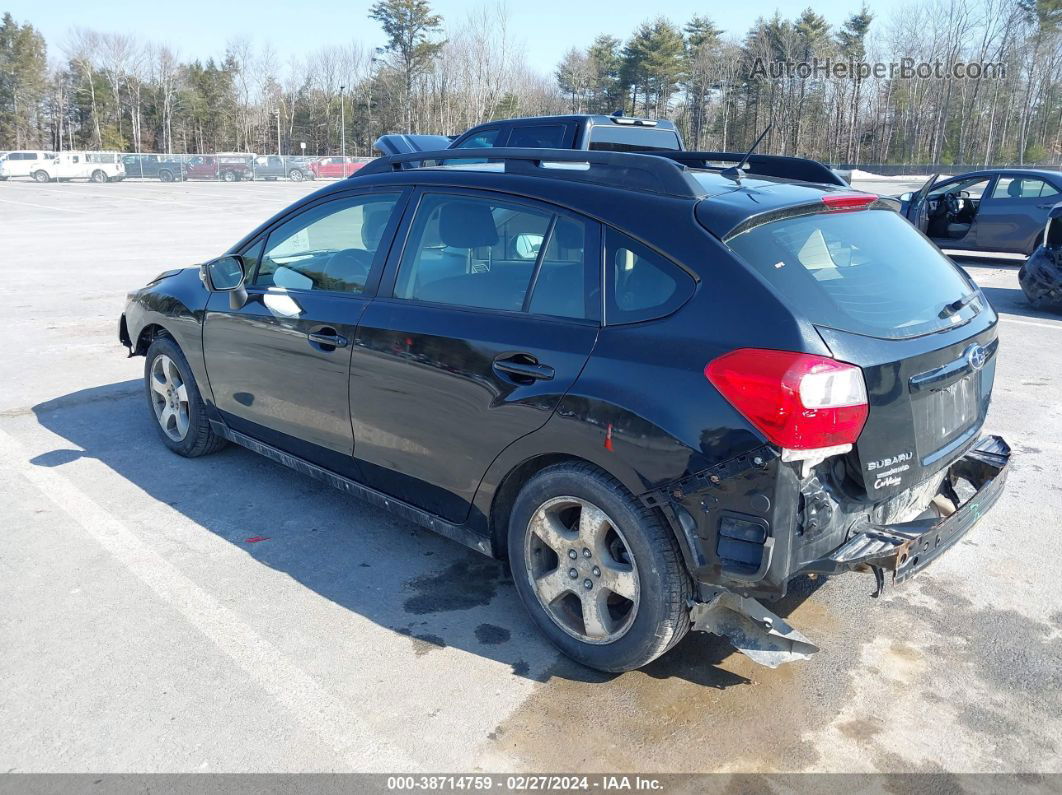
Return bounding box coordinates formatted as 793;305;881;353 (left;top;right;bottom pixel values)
900;169;1062;255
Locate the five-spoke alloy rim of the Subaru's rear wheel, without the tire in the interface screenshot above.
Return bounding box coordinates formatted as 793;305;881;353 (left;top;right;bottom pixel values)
524;497;640;644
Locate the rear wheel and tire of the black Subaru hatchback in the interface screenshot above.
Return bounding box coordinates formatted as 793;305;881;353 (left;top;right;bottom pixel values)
508;463;692;672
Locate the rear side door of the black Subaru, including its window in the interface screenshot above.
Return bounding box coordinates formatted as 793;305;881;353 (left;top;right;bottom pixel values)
350;185;601;521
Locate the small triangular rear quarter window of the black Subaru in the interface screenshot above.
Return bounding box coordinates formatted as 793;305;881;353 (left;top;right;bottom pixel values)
605;229;693;324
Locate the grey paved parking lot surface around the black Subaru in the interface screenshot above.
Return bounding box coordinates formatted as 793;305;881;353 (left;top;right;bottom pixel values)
0;175;1062;773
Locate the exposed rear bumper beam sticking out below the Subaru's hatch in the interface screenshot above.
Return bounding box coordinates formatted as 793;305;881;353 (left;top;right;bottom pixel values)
800;436;1010;583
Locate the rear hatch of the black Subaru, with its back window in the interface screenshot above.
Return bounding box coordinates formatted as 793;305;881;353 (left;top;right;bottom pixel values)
727;210;997;500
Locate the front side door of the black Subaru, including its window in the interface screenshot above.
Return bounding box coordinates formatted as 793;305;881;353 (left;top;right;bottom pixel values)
203;191;401;474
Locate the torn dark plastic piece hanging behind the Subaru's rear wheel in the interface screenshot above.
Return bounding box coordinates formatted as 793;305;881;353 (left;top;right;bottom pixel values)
689;591;819;668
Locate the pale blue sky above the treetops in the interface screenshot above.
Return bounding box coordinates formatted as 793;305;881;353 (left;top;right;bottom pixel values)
8;0;902;72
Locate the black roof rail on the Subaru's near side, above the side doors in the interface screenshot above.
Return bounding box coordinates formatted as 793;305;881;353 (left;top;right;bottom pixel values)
348;148;705;198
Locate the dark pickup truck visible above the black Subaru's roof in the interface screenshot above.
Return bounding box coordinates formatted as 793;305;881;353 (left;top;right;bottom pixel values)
376;114;684;155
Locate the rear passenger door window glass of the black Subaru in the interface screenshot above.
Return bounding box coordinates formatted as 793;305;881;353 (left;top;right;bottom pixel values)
395;194;596;318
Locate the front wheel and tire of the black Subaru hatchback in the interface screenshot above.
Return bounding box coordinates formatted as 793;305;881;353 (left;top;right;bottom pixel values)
143;336;225;459
